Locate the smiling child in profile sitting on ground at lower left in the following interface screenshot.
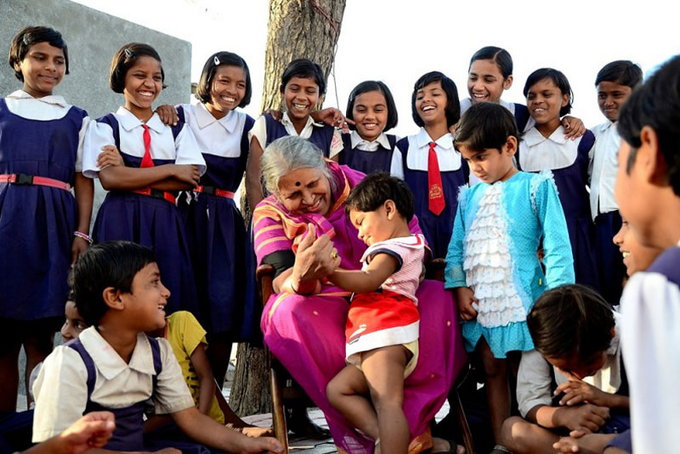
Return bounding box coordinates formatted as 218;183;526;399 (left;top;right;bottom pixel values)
33;241;281;453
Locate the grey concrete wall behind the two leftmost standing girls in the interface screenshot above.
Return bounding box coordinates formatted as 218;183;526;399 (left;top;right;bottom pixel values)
0;0;191;118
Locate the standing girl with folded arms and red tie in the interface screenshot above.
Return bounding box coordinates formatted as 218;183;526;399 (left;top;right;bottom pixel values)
83;43;205;313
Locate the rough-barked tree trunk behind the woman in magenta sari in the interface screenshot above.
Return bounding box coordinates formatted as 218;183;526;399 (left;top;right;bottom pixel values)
229;0;345;416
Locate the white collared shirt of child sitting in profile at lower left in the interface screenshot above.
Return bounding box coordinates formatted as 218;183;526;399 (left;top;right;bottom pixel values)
33;327;194;443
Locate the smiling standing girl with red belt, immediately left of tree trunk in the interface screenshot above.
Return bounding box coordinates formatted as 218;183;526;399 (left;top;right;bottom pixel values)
177;52;259;383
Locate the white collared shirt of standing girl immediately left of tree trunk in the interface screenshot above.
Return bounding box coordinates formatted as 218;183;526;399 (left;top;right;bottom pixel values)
181;103;247;158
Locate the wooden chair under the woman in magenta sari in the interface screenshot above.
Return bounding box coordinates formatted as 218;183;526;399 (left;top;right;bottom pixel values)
256;259;475;454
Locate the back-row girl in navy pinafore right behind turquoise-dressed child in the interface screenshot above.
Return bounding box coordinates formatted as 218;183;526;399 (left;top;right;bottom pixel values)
517;68;600;290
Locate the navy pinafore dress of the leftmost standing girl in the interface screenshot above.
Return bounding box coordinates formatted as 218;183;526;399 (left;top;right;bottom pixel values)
0;97;87;320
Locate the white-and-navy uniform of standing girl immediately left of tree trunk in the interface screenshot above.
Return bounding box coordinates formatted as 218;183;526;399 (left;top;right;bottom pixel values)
177;104;260;342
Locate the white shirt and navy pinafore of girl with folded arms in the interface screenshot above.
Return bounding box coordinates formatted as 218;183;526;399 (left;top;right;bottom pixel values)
83;107;205;314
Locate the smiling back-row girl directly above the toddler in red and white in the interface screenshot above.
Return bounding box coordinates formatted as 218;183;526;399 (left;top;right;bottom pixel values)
338;80;404;178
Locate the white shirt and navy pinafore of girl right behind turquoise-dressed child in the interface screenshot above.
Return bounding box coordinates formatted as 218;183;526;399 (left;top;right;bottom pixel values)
515;126;600;290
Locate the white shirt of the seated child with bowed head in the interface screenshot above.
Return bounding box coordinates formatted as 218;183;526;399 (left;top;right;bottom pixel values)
517;312;622;418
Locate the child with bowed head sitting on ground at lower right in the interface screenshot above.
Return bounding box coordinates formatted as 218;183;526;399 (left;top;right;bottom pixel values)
502;285;630;454
